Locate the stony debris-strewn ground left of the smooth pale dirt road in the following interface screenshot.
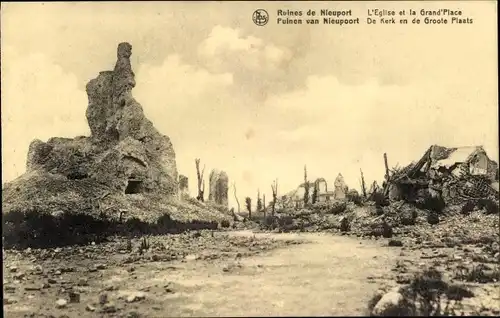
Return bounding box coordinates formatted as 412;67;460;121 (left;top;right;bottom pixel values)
4;230;302;315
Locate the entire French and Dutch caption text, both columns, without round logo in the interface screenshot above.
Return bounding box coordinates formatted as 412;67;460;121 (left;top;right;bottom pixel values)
276;9;473;25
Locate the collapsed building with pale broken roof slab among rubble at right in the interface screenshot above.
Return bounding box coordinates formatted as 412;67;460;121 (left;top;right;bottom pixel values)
384;145;498;204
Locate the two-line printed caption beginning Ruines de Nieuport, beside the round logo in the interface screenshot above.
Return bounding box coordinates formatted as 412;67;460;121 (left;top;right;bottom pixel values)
276;9;359;25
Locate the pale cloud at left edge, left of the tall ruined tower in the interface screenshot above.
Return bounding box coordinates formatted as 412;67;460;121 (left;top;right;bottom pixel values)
2;46;90;182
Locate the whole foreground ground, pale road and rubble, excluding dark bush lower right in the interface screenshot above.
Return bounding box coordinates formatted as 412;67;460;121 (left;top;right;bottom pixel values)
3;224;500;317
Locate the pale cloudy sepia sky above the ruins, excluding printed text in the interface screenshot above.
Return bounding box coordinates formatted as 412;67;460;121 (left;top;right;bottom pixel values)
1;1;498;210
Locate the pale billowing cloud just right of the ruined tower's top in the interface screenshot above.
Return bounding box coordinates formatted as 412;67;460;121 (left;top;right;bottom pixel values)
133;55;233;139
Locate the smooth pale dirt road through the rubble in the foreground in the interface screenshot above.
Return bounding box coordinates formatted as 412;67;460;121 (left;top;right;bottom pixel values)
126;232;399;317
